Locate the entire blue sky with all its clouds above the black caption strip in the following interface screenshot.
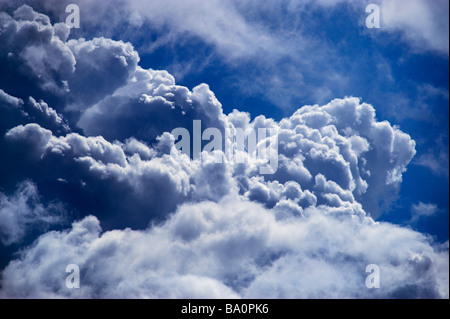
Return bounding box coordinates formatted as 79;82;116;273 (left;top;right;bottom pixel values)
0;0;449;298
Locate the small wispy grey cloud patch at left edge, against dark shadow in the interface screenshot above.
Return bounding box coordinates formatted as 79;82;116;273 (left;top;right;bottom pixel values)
0;181;65;246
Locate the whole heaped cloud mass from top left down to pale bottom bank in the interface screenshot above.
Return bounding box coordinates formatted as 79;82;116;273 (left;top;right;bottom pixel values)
0;6;448;298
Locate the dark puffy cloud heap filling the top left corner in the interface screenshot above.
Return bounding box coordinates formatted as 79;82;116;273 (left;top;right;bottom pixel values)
0;5;139;125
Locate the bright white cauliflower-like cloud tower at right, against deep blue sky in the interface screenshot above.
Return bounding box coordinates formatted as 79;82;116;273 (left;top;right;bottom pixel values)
236;98;416;218
